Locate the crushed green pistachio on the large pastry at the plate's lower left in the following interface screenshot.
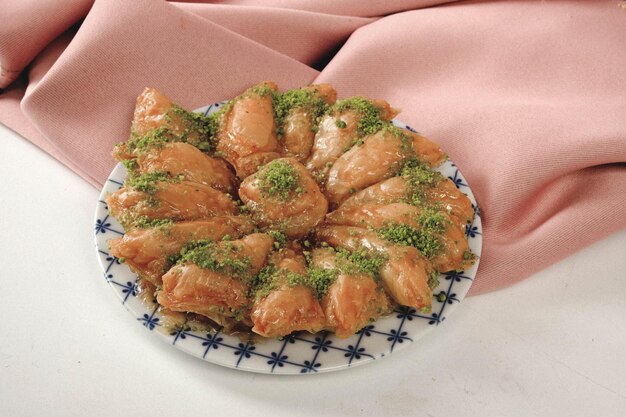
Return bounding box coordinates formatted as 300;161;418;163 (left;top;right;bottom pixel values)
178;239;254;282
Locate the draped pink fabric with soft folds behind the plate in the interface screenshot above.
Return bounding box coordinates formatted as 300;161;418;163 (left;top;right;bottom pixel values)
0;0;626;294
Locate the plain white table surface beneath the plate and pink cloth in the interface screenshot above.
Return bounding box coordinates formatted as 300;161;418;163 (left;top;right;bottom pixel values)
0;125;626;417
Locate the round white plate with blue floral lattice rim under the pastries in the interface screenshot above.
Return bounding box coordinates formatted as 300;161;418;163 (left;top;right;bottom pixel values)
95;102;482;374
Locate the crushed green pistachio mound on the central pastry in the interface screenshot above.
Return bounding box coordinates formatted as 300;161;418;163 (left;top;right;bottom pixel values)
256;160;304;201
